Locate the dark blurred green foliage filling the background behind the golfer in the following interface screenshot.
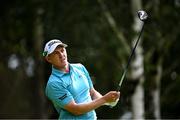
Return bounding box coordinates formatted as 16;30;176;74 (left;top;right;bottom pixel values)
0;0;180;119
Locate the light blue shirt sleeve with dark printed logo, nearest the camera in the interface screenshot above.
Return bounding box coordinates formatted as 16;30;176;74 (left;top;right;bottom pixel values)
46;82;73;108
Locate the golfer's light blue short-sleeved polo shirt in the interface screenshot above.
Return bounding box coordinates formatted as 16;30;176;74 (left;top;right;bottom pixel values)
45;64;96;120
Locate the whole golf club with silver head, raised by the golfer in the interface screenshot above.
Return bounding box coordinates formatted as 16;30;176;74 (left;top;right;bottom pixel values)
117;10;148;91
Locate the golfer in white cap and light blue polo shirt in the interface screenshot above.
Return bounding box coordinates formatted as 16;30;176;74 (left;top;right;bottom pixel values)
43;39;120;120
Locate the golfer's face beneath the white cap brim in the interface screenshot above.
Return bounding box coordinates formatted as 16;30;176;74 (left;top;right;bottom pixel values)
46;46;68;69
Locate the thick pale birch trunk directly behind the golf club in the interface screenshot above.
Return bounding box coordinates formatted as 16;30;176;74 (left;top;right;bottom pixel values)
131;0;144;120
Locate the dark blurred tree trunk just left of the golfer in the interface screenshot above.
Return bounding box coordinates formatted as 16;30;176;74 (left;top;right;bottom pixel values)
34;8;48;118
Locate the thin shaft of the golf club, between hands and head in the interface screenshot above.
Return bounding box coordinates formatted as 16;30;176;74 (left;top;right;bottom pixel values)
117;22;144;91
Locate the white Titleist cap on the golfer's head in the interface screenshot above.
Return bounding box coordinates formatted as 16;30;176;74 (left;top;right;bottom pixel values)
43;39;67;57
